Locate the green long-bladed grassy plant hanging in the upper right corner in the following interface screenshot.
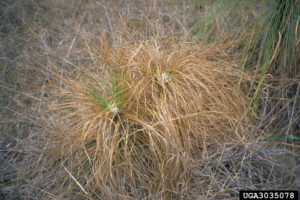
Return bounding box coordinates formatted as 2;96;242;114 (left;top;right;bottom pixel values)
191;0;300;139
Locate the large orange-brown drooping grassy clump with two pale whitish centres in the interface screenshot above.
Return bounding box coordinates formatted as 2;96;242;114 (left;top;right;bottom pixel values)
18;35;249;199
